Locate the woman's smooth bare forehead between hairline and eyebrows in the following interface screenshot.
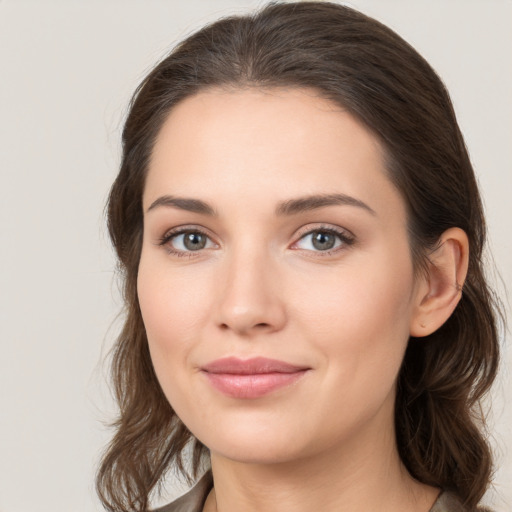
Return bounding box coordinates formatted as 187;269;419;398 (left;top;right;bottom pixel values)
144;88;404;222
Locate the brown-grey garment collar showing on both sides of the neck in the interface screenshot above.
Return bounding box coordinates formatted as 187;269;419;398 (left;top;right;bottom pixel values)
154;471;490;512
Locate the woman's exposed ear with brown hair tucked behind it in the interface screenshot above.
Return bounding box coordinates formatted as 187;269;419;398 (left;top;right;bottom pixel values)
410;228;469;337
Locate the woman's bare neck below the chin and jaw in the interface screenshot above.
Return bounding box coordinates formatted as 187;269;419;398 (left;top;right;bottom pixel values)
204;410;439;512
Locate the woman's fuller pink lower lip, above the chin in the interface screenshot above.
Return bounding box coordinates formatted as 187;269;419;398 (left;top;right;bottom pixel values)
204;370;307;398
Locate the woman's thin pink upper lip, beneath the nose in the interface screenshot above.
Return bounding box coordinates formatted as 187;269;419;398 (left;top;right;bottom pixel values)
201;357;308;375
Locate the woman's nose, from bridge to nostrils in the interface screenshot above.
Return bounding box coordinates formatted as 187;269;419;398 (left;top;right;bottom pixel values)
217;247;286;337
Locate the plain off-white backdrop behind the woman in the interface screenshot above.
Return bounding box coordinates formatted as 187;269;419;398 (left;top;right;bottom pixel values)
0;0;512;512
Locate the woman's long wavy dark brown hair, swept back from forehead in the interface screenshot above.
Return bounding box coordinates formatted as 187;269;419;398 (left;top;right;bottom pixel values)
97;2;498;512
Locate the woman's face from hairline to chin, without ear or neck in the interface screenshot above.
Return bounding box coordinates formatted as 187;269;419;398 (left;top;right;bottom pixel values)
138;89;426;462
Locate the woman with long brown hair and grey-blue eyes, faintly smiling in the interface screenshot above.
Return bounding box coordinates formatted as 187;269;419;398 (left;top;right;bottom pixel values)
98;2;498;512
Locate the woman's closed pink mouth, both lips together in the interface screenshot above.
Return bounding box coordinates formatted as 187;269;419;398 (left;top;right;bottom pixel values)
201;357;310;399
